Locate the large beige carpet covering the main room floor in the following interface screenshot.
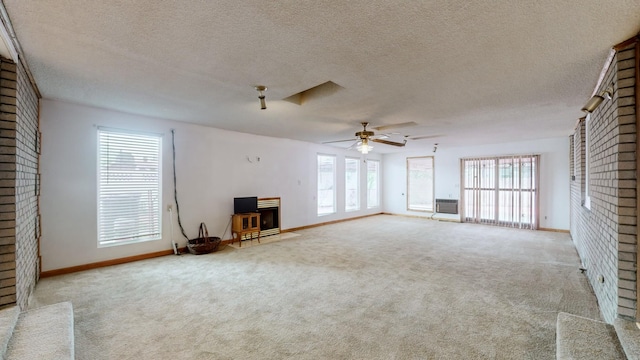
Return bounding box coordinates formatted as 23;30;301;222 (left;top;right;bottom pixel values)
32;215;599;360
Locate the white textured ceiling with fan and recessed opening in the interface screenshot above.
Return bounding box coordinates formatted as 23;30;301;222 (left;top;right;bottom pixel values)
3;0;640;152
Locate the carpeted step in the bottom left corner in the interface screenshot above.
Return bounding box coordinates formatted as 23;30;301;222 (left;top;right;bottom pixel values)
6;302;74;360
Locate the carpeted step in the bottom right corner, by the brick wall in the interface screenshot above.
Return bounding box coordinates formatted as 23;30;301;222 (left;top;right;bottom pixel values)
556;313;627;360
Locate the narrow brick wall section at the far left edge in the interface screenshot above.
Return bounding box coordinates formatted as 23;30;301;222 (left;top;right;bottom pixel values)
0;59;40;309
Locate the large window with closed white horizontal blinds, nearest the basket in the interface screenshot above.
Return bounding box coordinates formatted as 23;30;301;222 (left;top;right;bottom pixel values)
98;128;162;246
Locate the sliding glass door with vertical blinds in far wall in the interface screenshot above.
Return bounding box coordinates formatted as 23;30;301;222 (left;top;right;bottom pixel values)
462;155;539;229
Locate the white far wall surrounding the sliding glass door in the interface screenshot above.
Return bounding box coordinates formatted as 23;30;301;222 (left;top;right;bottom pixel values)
382;137;569;230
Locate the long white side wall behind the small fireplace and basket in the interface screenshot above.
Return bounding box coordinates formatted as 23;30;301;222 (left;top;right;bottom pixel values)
40;100;381;271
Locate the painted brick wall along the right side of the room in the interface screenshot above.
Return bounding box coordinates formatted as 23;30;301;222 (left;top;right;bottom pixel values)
571;45;637;322
